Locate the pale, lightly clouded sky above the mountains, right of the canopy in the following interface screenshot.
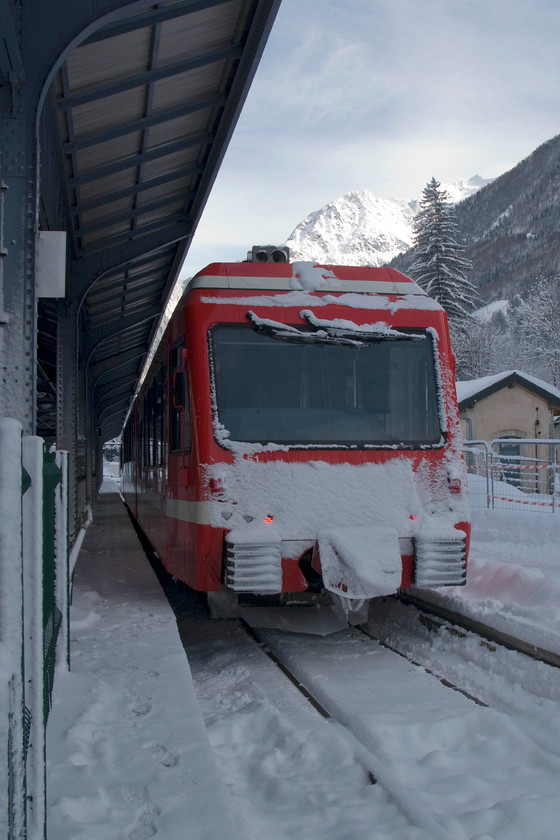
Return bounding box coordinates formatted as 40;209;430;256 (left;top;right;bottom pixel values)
178;0;560;276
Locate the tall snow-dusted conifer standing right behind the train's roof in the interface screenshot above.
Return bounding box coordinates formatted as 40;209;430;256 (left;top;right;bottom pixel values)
410;178;478;321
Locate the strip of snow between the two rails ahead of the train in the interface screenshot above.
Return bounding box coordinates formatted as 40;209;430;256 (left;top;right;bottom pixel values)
266;630;560;840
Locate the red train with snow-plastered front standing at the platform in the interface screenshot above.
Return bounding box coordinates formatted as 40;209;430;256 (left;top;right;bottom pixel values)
123;251;470;608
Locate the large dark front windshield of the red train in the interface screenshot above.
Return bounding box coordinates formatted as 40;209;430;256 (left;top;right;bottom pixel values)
210;324;443;448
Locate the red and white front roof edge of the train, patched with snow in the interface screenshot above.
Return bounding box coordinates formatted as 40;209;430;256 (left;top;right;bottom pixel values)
188;262;441;311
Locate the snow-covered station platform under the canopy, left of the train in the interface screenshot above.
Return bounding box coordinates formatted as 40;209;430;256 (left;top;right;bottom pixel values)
47;481;236;840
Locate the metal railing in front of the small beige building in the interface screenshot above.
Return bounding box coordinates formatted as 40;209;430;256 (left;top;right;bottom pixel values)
463;438;560;513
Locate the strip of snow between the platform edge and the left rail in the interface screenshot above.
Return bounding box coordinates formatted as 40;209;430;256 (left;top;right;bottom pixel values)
181;620;416;840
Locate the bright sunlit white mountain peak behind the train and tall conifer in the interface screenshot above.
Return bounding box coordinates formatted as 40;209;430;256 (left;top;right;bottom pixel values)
286;175;489;266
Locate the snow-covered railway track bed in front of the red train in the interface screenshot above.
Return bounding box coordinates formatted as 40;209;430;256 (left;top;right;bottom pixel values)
141;532;560;840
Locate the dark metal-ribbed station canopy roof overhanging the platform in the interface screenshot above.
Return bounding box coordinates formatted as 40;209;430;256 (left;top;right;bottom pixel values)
37;0;279;440
